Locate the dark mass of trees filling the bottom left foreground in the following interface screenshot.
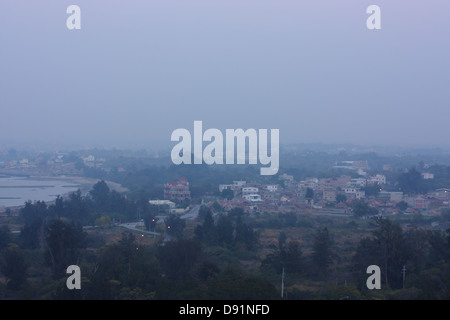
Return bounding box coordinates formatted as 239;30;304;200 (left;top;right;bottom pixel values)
0;228;278;300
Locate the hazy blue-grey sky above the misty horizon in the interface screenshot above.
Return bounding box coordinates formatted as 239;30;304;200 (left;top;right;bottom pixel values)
0;0;450;148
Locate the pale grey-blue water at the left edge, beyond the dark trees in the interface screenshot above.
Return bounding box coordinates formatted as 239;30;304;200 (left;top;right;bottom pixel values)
0;177;80;208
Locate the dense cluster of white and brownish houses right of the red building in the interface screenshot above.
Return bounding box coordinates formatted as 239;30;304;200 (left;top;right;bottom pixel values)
201;170;450;214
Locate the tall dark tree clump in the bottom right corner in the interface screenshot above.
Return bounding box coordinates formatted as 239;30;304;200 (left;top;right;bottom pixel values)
352;217;450;299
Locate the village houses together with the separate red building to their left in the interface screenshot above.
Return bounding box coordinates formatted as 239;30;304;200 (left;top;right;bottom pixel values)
164;161;450;220
